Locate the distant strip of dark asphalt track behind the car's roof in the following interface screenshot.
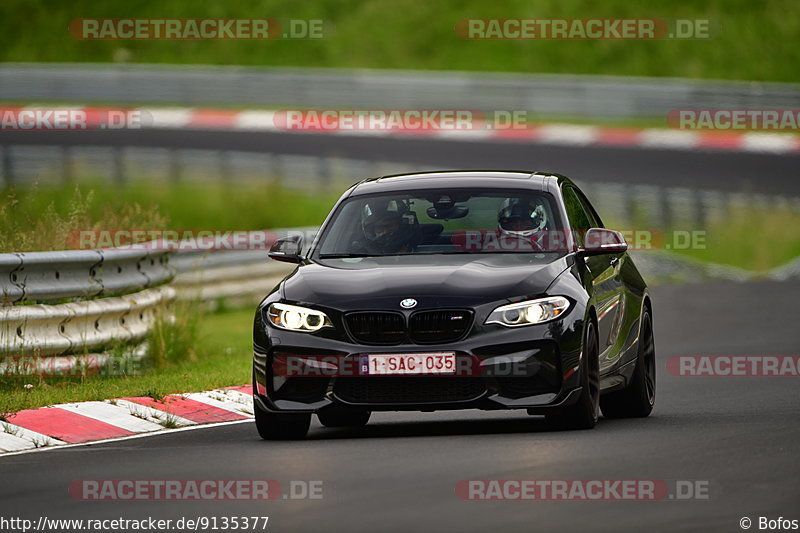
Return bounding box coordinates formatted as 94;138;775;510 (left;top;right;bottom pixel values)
6;130;800;196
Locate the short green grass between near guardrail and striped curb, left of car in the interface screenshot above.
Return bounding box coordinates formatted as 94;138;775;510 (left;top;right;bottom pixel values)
0;309;253;414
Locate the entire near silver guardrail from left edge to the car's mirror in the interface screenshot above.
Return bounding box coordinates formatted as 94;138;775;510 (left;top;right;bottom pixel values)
0;228;316;374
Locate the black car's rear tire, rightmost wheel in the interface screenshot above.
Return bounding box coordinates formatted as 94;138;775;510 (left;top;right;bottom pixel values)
600;311;656;418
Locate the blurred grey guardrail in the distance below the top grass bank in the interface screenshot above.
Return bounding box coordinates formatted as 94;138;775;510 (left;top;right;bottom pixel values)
0;63;800;118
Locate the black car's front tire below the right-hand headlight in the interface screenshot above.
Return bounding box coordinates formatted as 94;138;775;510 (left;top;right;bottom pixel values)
545;322;600;429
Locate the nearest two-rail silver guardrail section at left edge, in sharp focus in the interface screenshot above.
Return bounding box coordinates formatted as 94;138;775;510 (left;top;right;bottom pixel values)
0;244;175;374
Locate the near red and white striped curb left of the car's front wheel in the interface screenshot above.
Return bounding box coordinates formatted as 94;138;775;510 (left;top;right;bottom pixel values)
0;385;253;453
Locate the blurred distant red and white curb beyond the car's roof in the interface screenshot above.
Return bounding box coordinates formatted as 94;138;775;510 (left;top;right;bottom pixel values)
6;104;800;154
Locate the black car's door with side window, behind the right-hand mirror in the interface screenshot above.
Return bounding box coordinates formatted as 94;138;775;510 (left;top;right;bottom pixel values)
562;186;625;373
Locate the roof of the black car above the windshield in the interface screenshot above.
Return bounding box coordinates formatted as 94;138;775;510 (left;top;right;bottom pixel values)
350;170;572;196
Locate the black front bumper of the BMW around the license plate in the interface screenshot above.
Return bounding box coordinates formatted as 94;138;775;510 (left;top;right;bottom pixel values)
253;308;582;414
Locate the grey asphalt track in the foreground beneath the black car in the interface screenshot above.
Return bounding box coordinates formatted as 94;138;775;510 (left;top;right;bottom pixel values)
0;282;800;532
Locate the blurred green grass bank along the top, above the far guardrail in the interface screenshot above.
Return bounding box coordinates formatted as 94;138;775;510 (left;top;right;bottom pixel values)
0;0;800;82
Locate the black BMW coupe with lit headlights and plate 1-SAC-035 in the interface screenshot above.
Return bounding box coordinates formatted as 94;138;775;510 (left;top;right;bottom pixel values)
253;171;655;439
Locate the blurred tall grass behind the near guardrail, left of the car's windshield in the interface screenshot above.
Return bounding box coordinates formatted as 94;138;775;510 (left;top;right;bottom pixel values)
0;181;338;252
